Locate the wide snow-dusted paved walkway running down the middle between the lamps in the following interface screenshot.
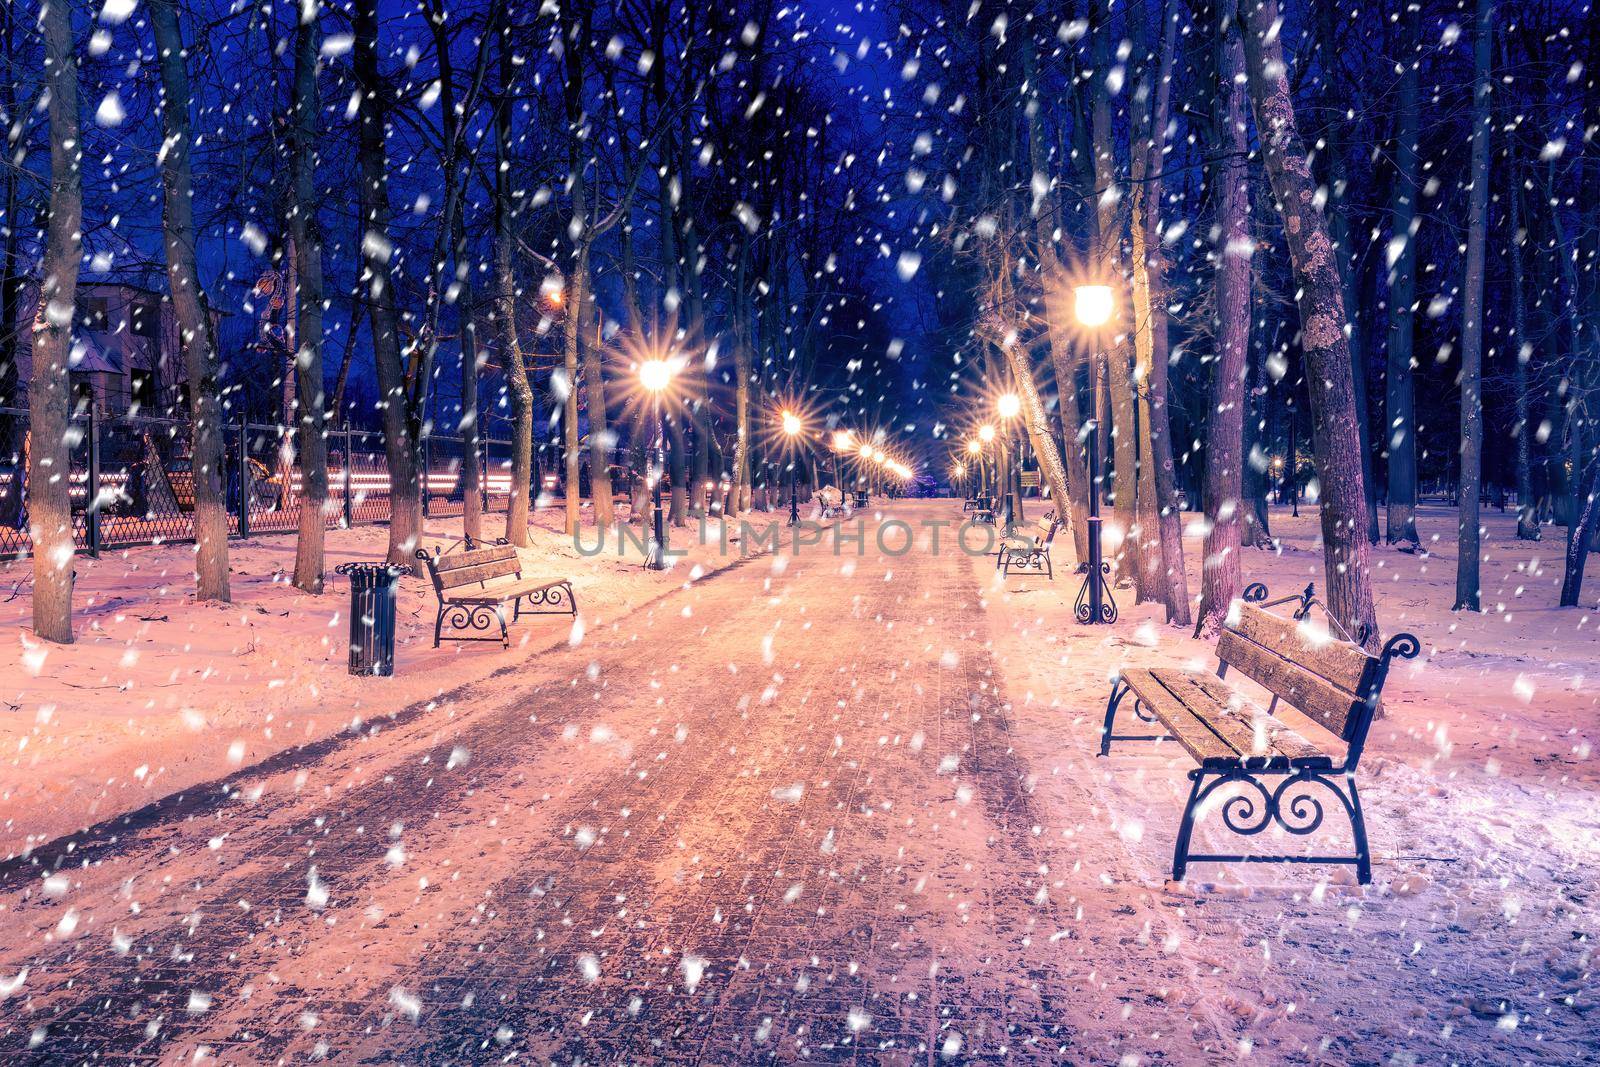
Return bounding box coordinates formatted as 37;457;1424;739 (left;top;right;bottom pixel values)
0;511;1104;1062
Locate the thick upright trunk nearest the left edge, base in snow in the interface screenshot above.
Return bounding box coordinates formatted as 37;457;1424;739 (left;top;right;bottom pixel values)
28;3;83;645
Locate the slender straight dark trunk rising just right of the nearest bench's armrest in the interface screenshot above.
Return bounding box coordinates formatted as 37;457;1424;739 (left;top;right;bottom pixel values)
1454;0;1494;611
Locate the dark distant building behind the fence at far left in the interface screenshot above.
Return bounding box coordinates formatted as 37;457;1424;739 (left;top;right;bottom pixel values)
0;278;200;416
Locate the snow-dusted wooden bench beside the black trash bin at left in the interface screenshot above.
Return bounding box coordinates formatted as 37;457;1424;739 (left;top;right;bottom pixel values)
416;537;578;648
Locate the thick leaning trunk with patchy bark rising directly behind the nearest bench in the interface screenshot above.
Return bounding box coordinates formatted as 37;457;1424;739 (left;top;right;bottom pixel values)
1240;0;1378;646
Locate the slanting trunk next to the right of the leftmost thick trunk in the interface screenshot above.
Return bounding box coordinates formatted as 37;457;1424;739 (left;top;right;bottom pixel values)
149;0;230;601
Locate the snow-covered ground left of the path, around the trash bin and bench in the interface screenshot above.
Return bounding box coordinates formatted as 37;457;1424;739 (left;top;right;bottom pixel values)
0;507;784;857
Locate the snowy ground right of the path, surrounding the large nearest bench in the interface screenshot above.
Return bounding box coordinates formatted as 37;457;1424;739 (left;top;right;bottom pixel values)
974;504;1600;1062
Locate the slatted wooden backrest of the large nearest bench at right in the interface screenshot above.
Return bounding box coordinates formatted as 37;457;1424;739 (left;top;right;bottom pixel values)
1216;601;1381;752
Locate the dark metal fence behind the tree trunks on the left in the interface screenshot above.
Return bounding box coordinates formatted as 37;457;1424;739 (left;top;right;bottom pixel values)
0;408;510;557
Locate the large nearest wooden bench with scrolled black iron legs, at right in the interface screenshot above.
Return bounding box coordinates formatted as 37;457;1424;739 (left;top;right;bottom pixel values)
1101;584;1419;885
